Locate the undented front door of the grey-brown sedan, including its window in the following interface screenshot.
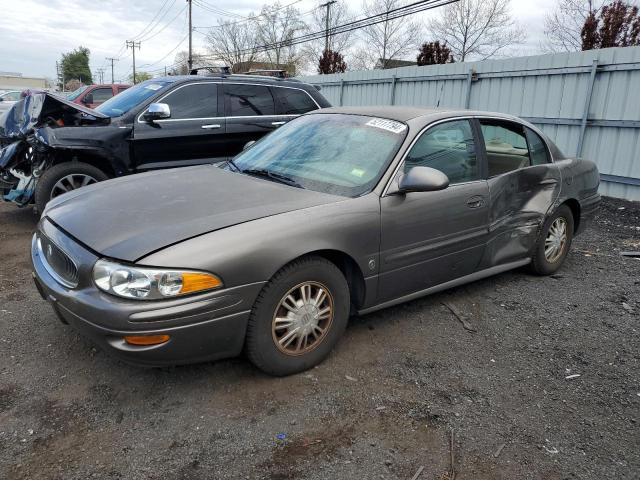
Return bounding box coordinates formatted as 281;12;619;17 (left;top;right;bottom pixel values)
379;120;489;301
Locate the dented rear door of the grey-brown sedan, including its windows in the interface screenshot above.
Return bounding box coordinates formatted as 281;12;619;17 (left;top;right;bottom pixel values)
478;118;561;266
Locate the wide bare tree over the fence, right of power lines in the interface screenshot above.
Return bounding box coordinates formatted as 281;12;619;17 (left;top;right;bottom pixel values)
429;0;525;62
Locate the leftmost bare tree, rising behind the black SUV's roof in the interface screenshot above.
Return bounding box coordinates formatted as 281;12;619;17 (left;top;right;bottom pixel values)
206;16;258;67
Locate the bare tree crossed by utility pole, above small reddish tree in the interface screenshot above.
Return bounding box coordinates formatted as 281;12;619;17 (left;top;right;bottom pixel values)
300;0;354;68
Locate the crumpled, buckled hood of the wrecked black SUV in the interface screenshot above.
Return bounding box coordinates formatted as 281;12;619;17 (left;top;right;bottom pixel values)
0;93;109;139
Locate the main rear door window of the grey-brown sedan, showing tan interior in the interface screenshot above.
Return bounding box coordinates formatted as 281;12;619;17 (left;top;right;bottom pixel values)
480;120;531;177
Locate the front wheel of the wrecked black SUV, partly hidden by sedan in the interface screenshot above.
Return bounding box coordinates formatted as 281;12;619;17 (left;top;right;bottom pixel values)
35;162;109;213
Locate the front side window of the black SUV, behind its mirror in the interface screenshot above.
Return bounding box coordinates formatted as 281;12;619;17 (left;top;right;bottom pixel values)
159;83;218;120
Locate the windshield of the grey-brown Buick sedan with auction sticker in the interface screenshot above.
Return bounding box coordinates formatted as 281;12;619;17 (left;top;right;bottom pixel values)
232;114;408;197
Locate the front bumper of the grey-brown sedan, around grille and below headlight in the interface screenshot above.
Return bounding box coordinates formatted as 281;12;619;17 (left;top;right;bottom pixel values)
31;221;263;366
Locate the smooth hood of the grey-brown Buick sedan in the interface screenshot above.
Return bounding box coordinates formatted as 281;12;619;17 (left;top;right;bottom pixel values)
43;165;343;262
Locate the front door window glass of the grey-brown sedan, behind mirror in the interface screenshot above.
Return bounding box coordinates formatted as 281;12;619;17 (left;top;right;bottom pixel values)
404;120;480;183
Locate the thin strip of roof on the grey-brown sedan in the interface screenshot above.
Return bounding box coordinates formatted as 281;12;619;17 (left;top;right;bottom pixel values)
309;105;522;122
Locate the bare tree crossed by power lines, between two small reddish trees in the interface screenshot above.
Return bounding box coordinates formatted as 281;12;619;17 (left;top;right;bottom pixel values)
358;0;423;68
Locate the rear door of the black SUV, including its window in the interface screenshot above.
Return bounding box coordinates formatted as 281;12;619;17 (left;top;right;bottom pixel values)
224;82;287;157
